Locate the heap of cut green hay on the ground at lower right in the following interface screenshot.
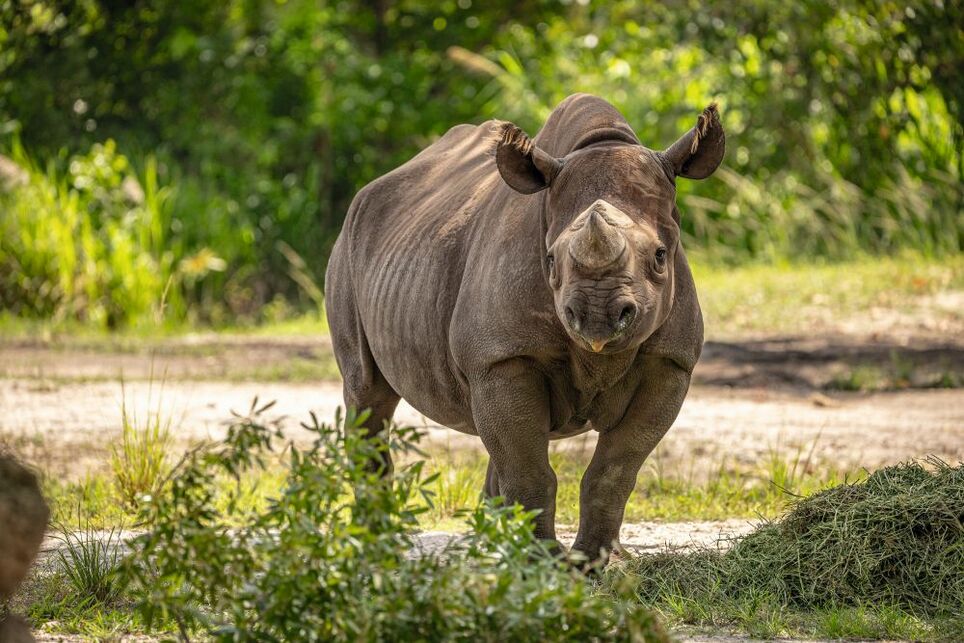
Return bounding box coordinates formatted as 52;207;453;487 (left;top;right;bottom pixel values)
629;459;964;620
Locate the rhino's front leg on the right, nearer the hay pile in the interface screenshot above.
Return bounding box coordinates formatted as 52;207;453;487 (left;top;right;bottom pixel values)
573;359;690;563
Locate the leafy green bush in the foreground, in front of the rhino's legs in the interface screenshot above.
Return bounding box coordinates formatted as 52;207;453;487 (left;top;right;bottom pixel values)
120;404;665;641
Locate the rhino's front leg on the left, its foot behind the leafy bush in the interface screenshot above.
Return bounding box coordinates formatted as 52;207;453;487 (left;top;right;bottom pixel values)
472;362;556;540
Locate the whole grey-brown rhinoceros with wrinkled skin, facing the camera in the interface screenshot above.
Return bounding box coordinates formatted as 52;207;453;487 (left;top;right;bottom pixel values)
325;94;724;561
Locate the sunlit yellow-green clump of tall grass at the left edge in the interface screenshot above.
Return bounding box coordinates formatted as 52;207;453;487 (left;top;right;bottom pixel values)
0;140;172;327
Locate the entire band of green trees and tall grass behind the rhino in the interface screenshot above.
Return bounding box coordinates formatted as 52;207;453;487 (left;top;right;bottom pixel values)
0;0;964;327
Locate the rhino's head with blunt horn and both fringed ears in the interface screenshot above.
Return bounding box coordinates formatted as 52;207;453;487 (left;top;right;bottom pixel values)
496;105;724;353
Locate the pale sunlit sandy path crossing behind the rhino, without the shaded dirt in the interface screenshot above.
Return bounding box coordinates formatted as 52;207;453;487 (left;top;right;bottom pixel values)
0;379;964;474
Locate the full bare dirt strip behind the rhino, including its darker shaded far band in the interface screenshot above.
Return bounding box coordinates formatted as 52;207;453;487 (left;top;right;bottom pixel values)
0;335;964;477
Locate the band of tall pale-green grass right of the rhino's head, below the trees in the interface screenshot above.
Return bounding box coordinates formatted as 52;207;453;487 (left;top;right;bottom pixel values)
681;166;964;263
